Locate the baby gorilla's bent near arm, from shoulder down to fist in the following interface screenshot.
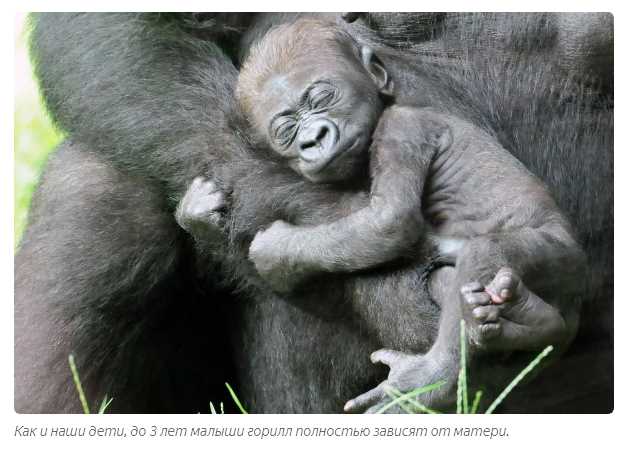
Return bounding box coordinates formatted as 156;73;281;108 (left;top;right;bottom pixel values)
249;108;449;292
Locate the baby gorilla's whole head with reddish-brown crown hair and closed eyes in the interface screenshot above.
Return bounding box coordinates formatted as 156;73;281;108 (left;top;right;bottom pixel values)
236;20;392;183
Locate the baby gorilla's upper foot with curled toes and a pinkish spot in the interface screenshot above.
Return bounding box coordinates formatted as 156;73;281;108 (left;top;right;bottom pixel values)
461;268;567;351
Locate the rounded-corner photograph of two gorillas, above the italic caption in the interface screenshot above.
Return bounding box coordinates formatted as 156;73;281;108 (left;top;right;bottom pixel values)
13;12;614;419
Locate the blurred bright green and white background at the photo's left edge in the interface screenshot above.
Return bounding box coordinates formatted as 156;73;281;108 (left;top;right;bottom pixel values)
13;14;62;245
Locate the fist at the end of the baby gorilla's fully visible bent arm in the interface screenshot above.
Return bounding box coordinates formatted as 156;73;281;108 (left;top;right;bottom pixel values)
249;220;300;292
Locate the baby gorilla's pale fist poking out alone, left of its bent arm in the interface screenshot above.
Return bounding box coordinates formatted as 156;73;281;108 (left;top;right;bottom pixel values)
175;177;226;240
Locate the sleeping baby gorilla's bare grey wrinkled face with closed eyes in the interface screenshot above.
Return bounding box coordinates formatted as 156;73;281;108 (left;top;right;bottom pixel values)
259;51;386;183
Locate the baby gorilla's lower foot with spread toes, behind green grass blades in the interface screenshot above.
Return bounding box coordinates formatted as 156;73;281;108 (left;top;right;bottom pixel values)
344;349;456;414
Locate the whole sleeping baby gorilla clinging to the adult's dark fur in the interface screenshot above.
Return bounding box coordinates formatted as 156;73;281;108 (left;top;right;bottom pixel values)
177;20;584;411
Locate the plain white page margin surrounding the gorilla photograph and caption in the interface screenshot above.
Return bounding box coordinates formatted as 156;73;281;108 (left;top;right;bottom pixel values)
0;0;640;461
